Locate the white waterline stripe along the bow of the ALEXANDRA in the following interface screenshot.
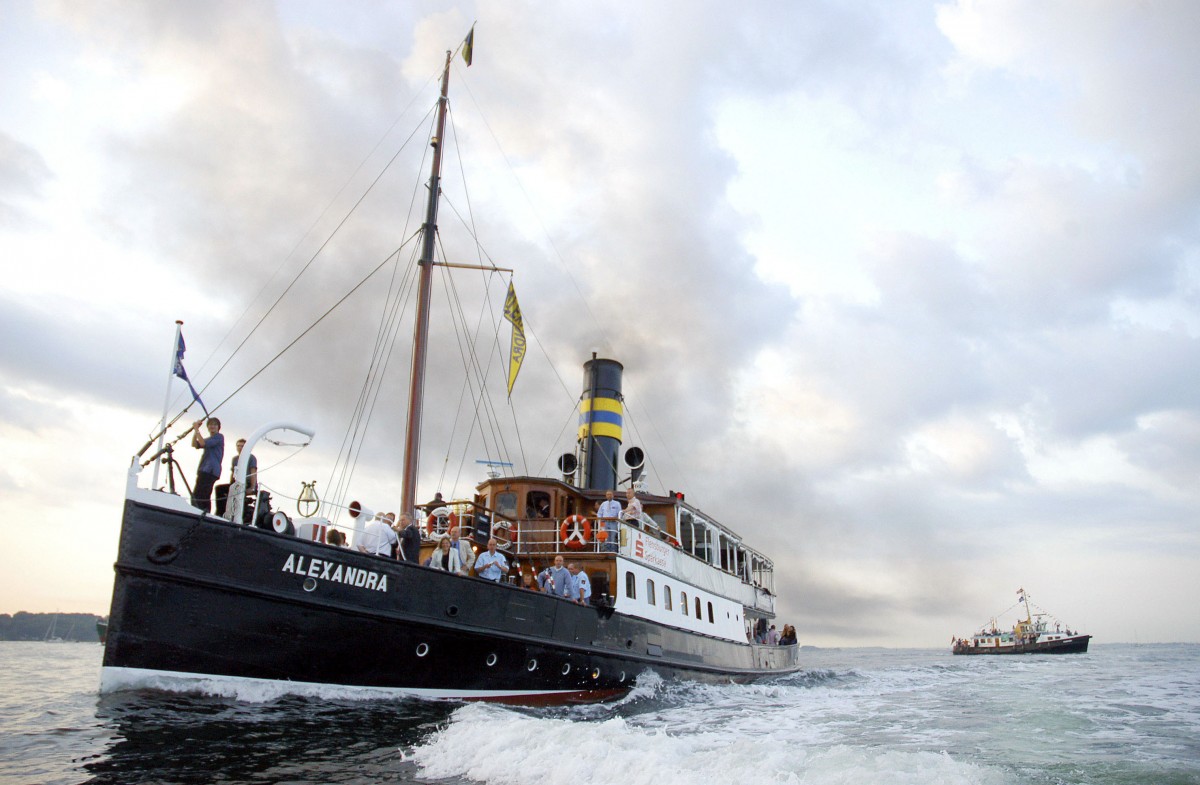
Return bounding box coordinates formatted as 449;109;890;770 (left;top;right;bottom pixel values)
100;666;586;702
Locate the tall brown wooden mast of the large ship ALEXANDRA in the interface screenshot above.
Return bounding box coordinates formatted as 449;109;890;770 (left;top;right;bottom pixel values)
400;50;452;513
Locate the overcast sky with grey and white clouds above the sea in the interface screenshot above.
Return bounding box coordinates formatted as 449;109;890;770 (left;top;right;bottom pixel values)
0;0;1200;646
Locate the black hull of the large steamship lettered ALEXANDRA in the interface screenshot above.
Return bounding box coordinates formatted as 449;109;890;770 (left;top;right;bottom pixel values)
103;502;798;700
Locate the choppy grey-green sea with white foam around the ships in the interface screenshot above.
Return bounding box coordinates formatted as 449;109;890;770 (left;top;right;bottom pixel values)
0;643;1200;785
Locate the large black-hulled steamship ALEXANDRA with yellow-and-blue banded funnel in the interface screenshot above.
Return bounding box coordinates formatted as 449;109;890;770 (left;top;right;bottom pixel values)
102;36;799;702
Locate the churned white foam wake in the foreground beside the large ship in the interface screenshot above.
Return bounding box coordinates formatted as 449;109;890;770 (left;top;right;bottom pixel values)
409;705;1014;785
